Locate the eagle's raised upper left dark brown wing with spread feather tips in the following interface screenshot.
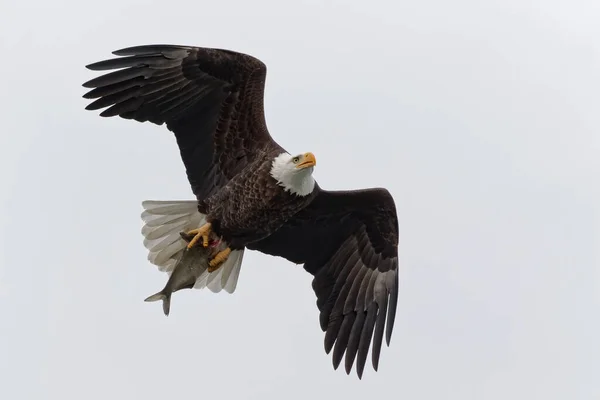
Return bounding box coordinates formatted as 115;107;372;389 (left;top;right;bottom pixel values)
83;45;279;201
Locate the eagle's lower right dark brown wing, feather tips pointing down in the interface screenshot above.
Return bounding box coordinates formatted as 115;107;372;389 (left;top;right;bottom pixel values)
248;189;398;377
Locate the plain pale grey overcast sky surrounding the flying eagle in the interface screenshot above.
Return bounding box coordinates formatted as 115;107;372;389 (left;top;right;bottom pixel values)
0;0;600;400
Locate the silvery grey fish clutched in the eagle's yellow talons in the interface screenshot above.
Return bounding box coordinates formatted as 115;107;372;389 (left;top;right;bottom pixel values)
144;232;220;316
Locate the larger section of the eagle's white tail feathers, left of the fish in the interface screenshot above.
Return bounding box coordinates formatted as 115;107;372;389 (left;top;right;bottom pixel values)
141;200;206;274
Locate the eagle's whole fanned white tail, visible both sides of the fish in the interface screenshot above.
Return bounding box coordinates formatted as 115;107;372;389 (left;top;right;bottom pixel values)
142;200;244;293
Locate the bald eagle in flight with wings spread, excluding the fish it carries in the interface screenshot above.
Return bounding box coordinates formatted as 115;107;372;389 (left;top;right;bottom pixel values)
83;45;398;378
